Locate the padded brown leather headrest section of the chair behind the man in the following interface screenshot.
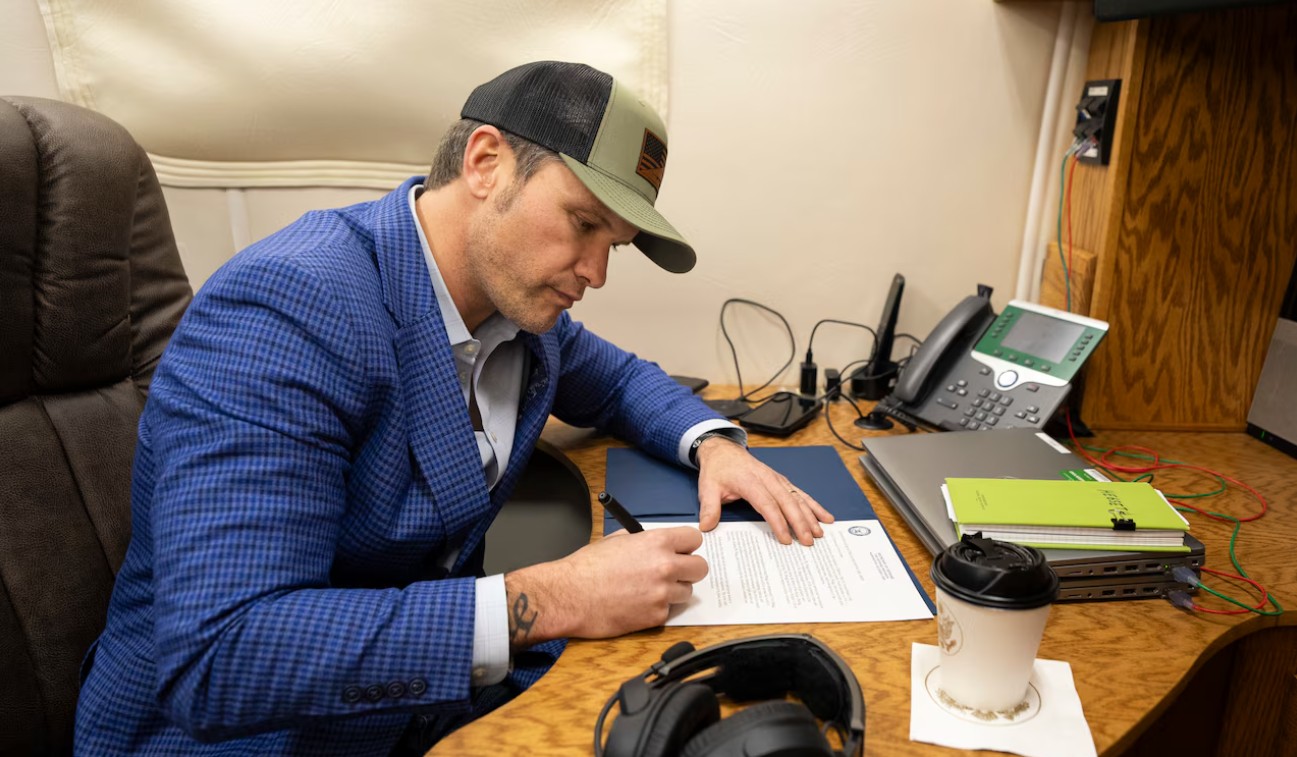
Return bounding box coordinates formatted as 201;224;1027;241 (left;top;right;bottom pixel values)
0;97;191;404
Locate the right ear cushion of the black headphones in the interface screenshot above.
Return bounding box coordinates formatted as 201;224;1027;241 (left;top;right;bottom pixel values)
680;700;833;757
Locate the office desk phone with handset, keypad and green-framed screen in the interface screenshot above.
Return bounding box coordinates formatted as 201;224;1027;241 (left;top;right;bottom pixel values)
878;294;1108;430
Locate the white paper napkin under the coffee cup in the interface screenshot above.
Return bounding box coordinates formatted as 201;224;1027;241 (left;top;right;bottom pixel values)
909;644;1097;757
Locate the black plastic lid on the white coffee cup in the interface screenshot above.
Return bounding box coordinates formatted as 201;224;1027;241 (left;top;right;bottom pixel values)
933;533;1058;609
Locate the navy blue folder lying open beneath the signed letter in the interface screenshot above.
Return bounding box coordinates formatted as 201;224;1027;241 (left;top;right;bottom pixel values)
603;445;936;612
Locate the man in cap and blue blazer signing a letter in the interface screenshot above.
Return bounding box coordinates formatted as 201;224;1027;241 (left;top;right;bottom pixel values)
77;62;831;754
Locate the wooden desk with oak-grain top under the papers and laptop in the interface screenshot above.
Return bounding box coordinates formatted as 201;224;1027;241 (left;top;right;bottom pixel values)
432;403;1297;756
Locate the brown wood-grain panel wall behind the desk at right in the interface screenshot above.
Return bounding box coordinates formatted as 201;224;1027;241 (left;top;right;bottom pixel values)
1073;5;1297;430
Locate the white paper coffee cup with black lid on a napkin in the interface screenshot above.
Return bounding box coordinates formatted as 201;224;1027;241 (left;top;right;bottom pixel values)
933;533;1058;712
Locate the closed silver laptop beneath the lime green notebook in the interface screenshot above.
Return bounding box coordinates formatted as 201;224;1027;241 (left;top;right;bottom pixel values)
860;429;1205;600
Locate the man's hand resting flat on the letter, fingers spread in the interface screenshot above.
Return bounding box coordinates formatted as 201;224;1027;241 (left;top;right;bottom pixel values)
694;437;833;546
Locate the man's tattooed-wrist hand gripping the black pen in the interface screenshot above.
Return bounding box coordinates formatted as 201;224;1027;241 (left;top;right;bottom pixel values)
505;526;707;651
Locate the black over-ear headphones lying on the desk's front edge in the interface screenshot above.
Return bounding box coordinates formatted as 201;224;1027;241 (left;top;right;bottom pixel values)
594;634;865;757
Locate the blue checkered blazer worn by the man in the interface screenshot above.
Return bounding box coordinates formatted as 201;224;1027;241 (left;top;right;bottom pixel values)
77;179;716;756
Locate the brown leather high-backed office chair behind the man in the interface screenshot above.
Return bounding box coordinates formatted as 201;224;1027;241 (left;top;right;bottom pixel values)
0;97;191;754
